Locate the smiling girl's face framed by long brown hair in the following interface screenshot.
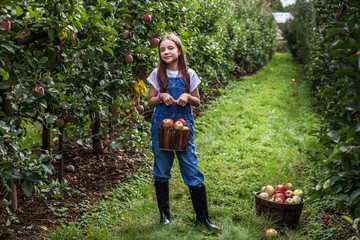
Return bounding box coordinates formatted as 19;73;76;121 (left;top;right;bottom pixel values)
160;39;181;70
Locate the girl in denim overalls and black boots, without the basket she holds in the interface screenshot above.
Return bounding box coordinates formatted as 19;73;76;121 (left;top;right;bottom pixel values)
148;34;219;229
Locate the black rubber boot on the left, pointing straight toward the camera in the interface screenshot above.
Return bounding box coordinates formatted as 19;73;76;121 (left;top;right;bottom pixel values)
155;181;170;225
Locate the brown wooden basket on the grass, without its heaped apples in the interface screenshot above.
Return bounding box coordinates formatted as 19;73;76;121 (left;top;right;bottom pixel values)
255;192;305;227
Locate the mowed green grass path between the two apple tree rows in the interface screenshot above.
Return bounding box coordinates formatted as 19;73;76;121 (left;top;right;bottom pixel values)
46;54;320;240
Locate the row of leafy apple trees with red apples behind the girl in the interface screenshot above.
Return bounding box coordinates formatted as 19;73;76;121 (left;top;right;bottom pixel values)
0;0;276;208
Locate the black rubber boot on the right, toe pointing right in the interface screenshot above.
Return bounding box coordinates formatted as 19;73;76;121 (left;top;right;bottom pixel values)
189;184;220;229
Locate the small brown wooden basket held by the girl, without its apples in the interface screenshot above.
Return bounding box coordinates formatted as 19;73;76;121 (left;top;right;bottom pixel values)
158;123;192;151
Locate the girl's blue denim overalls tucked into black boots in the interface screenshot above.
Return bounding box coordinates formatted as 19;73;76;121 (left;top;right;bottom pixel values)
151;77;204;186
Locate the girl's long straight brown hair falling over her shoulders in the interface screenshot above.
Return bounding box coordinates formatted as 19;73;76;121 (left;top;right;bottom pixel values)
156;34;190;93
